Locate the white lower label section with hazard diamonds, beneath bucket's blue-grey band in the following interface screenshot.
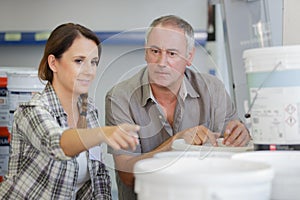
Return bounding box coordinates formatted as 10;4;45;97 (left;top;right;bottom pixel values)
250;87;300;144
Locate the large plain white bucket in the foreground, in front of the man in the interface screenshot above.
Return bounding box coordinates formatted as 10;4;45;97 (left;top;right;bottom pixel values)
134;158;274;200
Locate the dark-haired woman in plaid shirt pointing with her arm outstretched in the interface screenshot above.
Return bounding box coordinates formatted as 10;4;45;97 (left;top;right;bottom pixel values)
0;23;139;200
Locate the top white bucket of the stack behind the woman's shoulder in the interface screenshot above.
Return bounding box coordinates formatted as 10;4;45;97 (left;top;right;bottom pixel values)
7;68;45;131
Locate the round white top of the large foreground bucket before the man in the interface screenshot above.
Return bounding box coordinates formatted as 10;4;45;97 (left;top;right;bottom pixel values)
134;158;274;185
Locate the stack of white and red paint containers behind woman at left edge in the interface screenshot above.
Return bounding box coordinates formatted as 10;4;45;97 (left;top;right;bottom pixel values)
0;67;45;182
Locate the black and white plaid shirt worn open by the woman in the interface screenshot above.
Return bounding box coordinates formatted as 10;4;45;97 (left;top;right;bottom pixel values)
0;83;111;200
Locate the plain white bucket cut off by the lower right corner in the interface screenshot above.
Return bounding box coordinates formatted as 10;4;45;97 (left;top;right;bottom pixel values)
232;151;300;200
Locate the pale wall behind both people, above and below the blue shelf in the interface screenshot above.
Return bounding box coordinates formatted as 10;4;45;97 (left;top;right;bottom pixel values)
0;0;211;119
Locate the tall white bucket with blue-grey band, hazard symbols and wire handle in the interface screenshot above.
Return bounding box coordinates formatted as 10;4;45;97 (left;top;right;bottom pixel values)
243;45;300;150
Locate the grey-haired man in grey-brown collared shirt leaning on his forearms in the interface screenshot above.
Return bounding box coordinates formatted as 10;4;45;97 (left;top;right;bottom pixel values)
106;15;250;200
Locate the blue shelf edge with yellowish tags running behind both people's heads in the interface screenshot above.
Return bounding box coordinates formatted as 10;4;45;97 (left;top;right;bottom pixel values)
0;31;207;46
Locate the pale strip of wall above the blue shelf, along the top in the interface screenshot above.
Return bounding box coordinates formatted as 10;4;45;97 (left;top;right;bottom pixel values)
0;0;207;31
